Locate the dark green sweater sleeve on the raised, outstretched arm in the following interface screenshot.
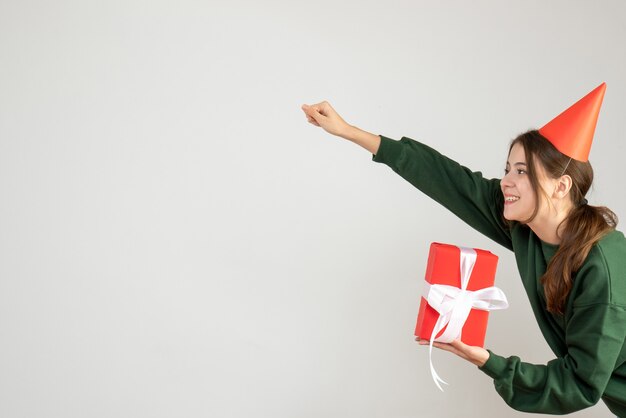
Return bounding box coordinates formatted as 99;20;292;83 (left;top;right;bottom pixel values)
372;135;513;250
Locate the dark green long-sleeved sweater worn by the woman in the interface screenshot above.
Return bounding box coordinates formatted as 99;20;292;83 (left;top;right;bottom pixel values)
372;136;626;417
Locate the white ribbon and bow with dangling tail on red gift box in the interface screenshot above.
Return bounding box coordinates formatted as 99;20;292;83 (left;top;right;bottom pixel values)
424;247;509;392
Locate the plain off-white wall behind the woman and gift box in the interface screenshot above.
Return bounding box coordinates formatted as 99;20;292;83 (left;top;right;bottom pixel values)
0;0;626;418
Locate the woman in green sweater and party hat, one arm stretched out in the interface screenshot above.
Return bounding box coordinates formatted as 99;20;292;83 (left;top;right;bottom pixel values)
302;84;626;417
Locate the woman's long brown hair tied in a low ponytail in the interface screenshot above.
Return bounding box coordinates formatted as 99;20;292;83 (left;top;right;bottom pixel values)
509;130;617;314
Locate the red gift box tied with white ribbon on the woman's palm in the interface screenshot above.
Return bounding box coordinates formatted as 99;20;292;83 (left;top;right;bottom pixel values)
415;242;498;347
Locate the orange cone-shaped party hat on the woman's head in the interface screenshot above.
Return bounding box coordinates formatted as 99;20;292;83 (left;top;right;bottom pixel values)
539;83;606;162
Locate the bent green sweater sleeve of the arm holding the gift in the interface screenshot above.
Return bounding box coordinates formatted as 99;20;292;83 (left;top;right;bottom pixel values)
479;303;626;414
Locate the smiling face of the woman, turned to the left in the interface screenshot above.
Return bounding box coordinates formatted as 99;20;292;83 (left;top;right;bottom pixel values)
500;144;544;222
